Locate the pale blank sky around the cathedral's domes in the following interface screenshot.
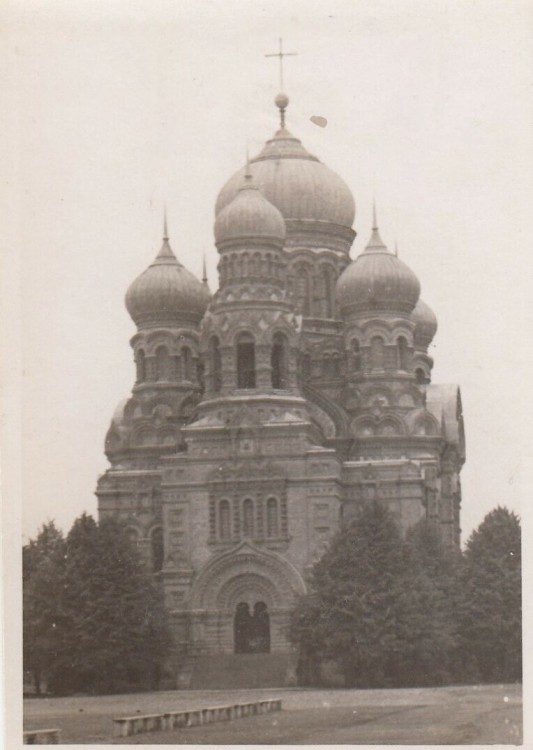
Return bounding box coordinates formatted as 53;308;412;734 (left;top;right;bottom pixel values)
2;0;533;539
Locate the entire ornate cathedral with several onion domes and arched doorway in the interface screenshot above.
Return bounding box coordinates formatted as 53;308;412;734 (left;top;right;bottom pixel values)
97;89;465;685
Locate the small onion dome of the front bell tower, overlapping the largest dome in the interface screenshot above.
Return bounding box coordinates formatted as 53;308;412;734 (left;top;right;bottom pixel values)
215;170;285;246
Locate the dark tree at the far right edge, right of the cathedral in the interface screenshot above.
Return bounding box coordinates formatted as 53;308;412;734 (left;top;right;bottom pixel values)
459;507;522;682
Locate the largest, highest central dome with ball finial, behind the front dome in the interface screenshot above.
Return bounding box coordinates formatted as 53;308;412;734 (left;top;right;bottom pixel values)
215;94;355;252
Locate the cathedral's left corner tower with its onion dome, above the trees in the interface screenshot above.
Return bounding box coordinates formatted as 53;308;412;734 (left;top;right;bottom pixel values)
96;216;211;574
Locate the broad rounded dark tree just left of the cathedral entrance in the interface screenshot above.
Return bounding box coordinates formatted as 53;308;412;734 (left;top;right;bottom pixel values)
51;514;170;693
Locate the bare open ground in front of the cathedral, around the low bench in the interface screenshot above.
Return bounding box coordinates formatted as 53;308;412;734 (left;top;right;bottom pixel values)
24;685;522;745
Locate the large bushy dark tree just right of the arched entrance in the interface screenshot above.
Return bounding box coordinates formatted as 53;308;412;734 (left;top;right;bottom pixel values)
291;503;451;687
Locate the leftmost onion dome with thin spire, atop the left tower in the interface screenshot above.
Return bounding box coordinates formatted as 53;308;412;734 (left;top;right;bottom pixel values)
126;221;211;327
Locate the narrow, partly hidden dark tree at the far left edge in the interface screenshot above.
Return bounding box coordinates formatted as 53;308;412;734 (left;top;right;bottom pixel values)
22;521;65;695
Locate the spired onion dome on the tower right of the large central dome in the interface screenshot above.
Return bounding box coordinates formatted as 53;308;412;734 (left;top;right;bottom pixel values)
337;210;420;317
